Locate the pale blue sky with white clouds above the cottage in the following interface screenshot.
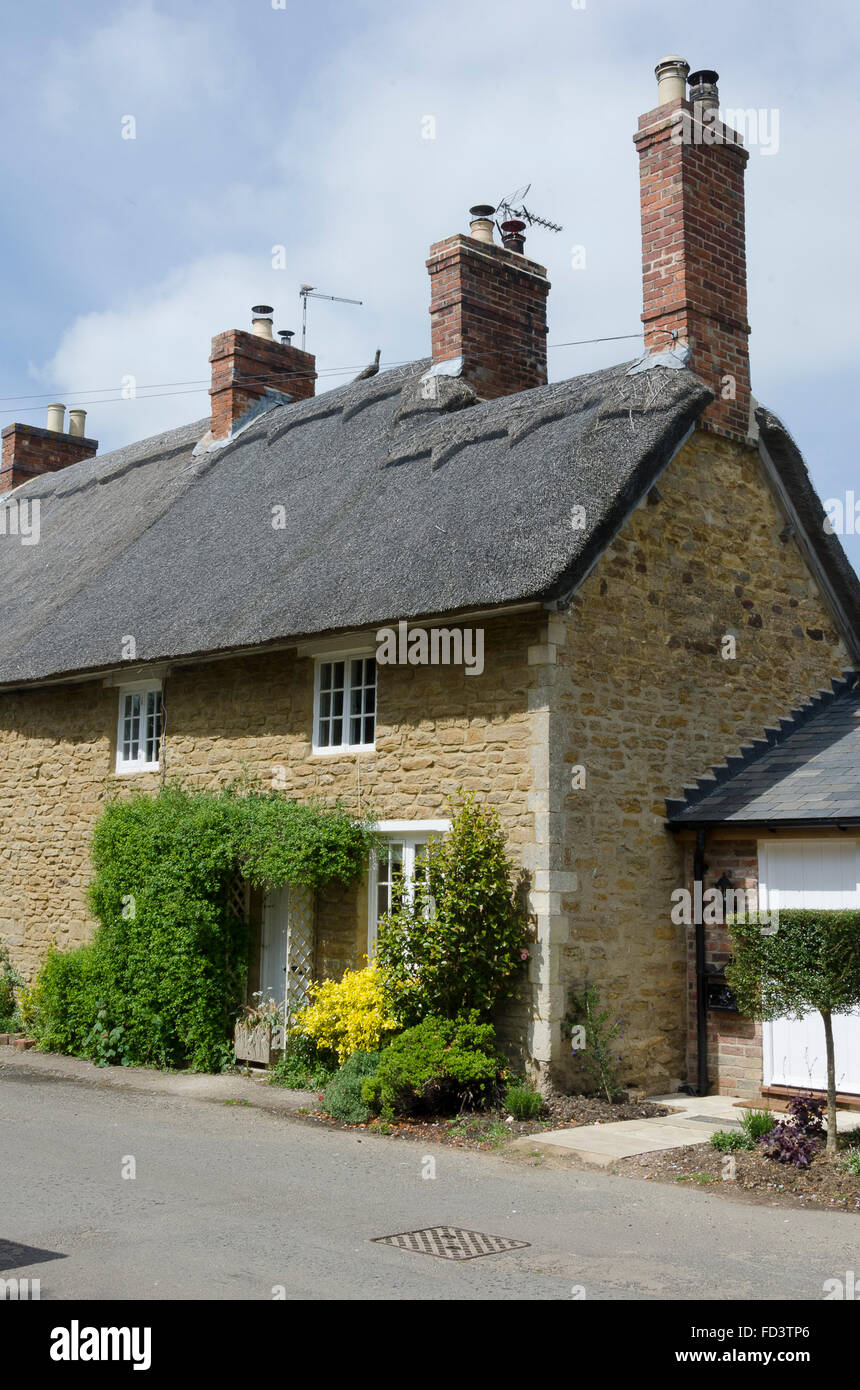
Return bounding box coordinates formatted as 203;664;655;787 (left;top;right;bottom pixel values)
0;0;860;570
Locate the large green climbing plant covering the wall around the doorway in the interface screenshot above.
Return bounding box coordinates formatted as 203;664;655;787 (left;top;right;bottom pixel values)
31;784;374;1070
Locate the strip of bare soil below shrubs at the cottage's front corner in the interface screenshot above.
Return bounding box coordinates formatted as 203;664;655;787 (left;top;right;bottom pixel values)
300;1094;670;1150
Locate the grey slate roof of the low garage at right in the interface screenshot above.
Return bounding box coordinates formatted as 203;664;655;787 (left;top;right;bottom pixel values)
667;671;860;827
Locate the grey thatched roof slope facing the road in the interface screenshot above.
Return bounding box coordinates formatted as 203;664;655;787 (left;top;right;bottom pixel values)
0;361;711;685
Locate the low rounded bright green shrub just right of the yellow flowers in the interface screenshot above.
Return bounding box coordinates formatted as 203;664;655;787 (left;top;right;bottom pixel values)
361;1016;506;1118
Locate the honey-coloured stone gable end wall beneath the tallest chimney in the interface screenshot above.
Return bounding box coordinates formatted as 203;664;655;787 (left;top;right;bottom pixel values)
545;431;849;1090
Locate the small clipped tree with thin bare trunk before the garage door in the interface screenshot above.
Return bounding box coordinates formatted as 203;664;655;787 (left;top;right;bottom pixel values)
725;908;860;1154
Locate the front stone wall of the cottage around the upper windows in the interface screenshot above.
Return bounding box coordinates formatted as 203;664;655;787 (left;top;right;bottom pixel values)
0;613;538;995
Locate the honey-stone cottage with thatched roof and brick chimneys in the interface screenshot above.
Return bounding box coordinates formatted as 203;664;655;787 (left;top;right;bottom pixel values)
0;58;860;1090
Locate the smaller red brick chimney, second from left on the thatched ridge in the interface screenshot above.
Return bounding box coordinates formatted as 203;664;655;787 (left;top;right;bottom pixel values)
208;304;317;439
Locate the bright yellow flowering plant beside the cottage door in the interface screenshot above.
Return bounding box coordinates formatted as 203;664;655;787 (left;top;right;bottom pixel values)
292;965;399;1063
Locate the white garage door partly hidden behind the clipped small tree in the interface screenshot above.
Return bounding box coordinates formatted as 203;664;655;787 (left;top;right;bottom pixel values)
759;840;860;1094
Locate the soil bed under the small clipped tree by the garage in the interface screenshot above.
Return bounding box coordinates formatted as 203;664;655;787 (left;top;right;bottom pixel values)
609;1144;860;1212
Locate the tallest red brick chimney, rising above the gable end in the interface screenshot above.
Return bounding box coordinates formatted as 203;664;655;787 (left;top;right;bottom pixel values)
634;56;750;439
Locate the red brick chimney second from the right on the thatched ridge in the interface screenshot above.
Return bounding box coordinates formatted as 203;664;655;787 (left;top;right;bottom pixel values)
427;204;550;400
